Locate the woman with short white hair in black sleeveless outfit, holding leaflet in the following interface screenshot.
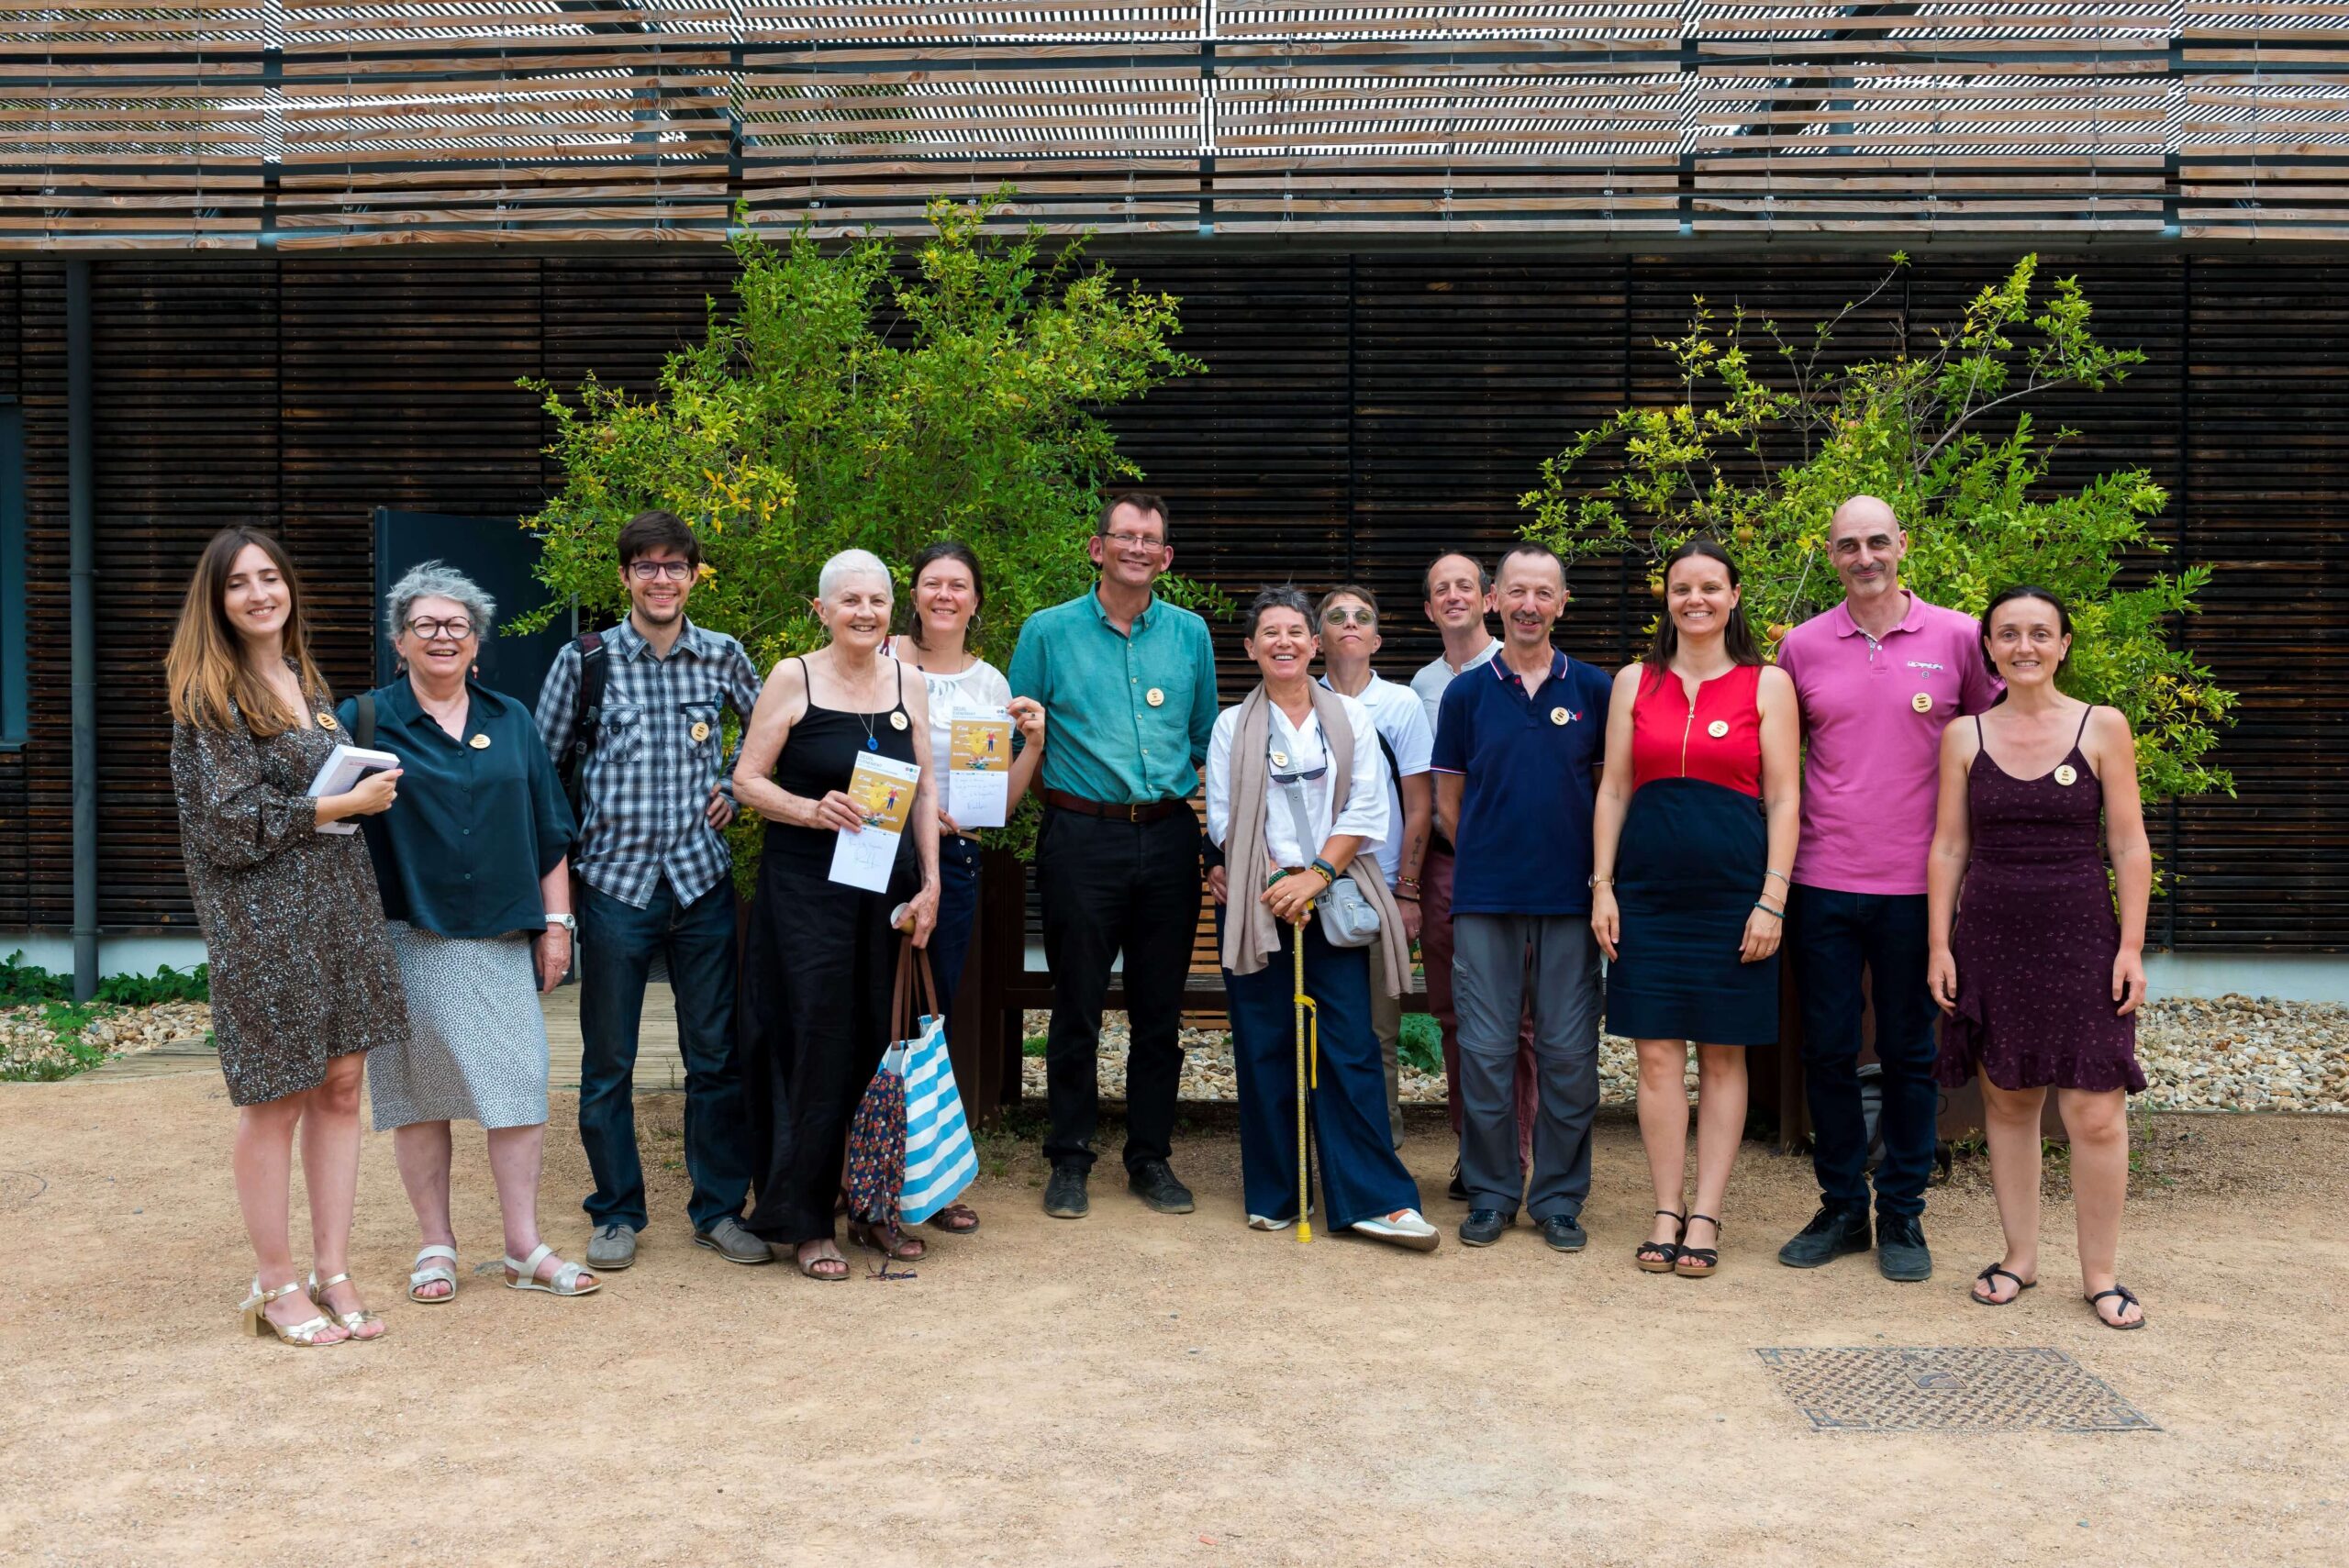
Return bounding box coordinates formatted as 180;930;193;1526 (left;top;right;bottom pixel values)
733;550;937;1279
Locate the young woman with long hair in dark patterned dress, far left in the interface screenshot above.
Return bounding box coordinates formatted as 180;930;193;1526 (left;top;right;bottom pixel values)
164;528;408;1345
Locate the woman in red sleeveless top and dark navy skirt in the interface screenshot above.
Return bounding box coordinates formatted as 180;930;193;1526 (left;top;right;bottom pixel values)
1590;539;1802;1279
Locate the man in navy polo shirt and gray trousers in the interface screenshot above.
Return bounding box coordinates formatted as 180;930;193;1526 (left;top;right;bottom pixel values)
1435;545;1614;1251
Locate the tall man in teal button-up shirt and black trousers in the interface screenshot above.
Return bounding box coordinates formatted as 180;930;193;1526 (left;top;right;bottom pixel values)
1010;493;1215;1220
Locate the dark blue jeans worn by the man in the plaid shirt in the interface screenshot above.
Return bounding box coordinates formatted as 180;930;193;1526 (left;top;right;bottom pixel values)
578;878;750;1230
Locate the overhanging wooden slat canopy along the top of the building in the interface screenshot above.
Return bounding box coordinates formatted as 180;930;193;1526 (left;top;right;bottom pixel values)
0;0;2349;251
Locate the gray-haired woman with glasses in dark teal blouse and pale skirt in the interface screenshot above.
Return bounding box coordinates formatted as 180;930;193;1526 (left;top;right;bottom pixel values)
340;561;601;1305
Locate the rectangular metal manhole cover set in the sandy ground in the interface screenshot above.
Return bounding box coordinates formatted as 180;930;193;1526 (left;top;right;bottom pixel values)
1754;1345;2161;1432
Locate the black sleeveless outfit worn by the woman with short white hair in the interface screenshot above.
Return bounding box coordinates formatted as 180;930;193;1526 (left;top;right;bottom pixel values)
740;660;921;1247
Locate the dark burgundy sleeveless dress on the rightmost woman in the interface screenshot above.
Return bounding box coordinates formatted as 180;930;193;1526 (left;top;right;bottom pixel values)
1933;709;2144;1094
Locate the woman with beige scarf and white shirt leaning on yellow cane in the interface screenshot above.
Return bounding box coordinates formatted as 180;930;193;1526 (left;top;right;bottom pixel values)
1208;587;1440;1251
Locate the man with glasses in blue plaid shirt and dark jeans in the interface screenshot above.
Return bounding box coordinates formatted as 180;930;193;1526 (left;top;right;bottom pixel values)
538;512;768;1270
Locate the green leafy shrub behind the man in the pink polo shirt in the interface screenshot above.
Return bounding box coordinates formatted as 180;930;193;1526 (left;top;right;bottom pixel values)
1522;256;2236;798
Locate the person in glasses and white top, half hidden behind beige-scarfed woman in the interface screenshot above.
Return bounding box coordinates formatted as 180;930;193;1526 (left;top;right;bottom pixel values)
1316;582;1435;1148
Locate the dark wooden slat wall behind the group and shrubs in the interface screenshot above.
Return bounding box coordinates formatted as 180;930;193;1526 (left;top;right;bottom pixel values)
0;244;2349;951
